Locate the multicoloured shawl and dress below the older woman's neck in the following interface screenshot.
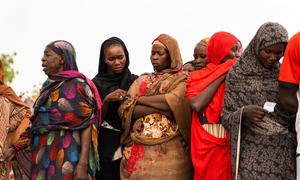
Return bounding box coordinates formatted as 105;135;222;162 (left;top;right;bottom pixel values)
31;70;101;179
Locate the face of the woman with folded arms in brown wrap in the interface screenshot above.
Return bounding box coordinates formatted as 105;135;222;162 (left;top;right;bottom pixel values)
150;44;171;72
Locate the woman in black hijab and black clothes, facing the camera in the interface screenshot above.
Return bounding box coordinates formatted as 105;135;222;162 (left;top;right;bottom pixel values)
92;37;137;180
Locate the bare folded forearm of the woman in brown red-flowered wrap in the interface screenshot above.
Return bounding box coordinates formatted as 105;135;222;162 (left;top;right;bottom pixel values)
137;95;170;112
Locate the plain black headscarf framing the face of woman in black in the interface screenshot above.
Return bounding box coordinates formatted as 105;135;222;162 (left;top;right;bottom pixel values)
92;37;137;104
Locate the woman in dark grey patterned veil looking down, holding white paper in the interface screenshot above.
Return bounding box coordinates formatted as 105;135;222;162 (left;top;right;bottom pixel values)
222;22;296;179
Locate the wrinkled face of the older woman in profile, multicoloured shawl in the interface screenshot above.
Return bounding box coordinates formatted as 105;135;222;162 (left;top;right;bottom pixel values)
42;47;65;76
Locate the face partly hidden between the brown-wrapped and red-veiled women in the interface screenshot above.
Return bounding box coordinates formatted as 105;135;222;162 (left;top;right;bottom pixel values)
193;44;208;70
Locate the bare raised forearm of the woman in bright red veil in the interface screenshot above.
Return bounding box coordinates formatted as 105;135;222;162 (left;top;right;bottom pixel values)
189;75;226;112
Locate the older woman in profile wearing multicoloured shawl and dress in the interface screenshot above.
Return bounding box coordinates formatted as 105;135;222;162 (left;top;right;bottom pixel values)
31;40;101;179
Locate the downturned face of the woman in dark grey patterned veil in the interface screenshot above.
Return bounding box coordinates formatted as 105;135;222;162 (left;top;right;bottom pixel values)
258;43;284;69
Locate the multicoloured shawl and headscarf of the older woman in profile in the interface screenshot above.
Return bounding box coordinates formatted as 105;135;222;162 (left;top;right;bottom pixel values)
31;40;102;172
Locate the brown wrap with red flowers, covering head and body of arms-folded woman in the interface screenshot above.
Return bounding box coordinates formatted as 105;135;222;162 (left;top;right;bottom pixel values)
119;34;192;179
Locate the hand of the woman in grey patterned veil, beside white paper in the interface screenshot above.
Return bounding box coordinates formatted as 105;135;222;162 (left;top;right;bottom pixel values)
242;105;268;121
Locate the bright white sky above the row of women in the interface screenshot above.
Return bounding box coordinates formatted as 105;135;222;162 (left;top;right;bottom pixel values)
0;0;300;93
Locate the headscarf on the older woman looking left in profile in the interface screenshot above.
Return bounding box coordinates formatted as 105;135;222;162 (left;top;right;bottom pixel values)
46;40;78;71
